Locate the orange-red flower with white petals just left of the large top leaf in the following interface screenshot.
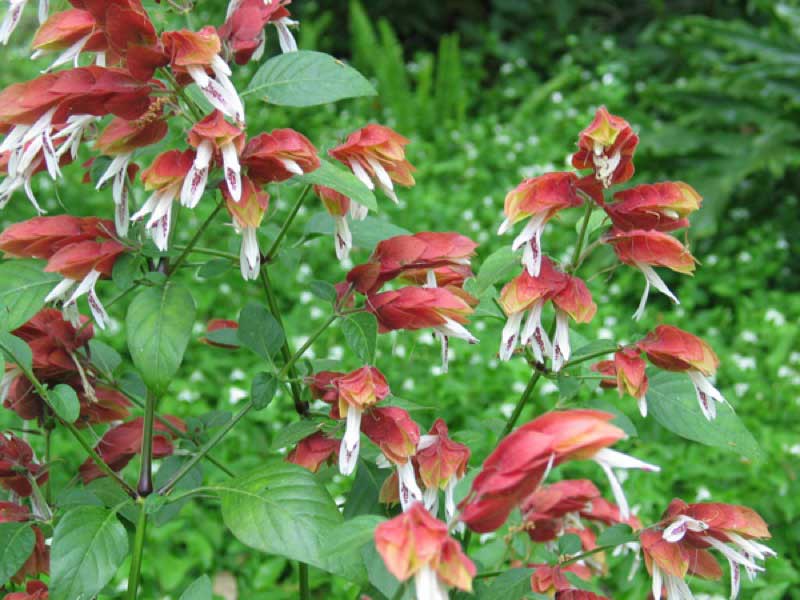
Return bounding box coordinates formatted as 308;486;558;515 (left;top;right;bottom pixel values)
161;26;244;124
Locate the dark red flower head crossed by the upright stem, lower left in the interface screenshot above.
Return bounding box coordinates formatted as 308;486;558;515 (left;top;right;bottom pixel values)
80;416;186;484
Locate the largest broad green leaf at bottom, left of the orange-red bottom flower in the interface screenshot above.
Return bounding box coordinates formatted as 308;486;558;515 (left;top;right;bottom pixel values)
220;460;366;581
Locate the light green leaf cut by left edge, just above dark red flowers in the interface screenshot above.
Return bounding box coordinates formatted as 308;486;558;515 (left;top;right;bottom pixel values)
0;260;61;331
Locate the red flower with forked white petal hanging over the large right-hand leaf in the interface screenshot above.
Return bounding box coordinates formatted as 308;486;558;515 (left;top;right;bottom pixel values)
636;325;725;421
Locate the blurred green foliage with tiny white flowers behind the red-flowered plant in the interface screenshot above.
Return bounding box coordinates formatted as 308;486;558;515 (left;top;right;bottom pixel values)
0;0;800;600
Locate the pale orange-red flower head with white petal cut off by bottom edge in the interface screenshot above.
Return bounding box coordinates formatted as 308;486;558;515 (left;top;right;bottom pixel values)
375;502;476;599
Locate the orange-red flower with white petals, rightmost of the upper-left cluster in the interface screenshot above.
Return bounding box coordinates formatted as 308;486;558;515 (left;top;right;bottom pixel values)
329;124;415;203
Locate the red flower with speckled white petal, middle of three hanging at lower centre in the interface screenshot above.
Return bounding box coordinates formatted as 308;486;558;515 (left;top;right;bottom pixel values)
364;406;422;510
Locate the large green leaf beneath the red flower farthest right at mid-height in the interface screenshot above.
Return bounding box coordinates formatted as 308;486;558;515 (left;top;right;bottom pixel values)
647;371;761;459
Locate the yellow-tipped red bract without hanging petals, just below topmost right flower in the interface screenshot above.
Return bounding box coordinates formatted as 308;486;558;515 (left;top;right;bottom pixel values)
603;181;703;231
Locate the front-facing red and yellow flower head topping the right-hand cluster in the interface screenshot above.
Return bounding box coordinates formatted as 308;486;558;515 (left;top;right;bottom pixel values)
572;106;639;188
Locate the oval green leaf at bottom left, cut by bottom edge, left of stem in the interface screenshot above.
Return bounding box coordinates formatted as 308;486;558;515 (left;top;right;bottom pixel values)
50;506;128;600
